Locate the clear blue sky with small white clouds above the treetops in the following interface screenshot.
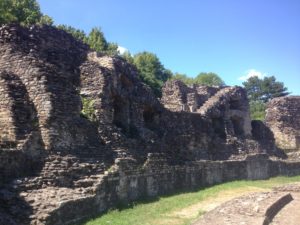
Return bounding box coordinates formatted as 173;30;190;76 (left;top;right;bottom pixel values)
38;0;300;95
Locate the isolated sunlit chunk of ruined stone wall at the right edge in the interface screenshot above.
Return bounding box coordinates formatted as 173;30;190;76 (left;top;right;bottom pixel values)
266;96;300;151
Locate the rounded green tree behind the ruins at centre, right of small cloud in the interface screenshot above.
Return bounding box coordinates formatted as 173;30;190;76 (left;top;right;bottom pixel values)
133;52;172;97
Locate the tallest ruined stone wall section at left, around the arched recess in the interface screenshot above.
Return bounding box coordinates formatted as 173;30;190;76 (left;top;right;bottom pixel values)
0;26;102;151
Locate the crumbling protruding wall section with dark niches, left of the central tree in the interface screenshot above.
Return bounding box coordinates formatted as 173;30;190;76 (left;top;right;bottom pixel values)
80;52;163;157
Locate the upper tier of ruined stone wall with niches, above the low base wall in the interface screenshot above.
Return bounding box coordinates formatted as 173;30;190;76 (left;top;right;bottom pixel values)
0;23;278;162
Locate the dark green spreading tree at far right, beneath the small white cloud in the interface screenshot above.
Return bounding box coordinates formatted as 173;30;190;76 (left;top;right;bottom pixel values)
243;76;289;102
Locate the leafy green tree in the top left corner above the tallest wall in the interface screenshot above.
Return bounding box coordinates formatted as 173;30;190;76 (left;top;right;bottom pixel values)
0;0;53;26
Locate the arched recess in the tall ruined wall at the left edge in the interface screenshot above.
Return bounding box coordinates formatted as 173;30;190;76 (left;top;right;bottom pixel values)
0;72;38;148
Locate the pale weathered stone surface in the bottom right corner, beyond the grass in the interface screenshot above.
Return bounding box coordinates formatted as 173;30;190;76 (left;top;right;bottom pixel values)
193;183;300;225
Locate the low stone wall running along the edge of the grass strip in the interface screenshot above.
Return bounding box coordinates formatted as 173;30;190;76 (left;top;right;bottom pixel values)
46;155;300;225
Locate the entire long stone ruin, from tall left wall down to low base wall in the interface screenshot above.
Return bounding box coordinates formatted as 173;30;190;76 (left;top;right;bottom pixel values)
0;25;300;225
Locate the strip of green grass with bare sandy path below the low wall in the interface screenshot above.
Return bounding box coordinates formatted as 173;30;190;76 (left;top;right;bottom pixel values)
85;176;300;225
